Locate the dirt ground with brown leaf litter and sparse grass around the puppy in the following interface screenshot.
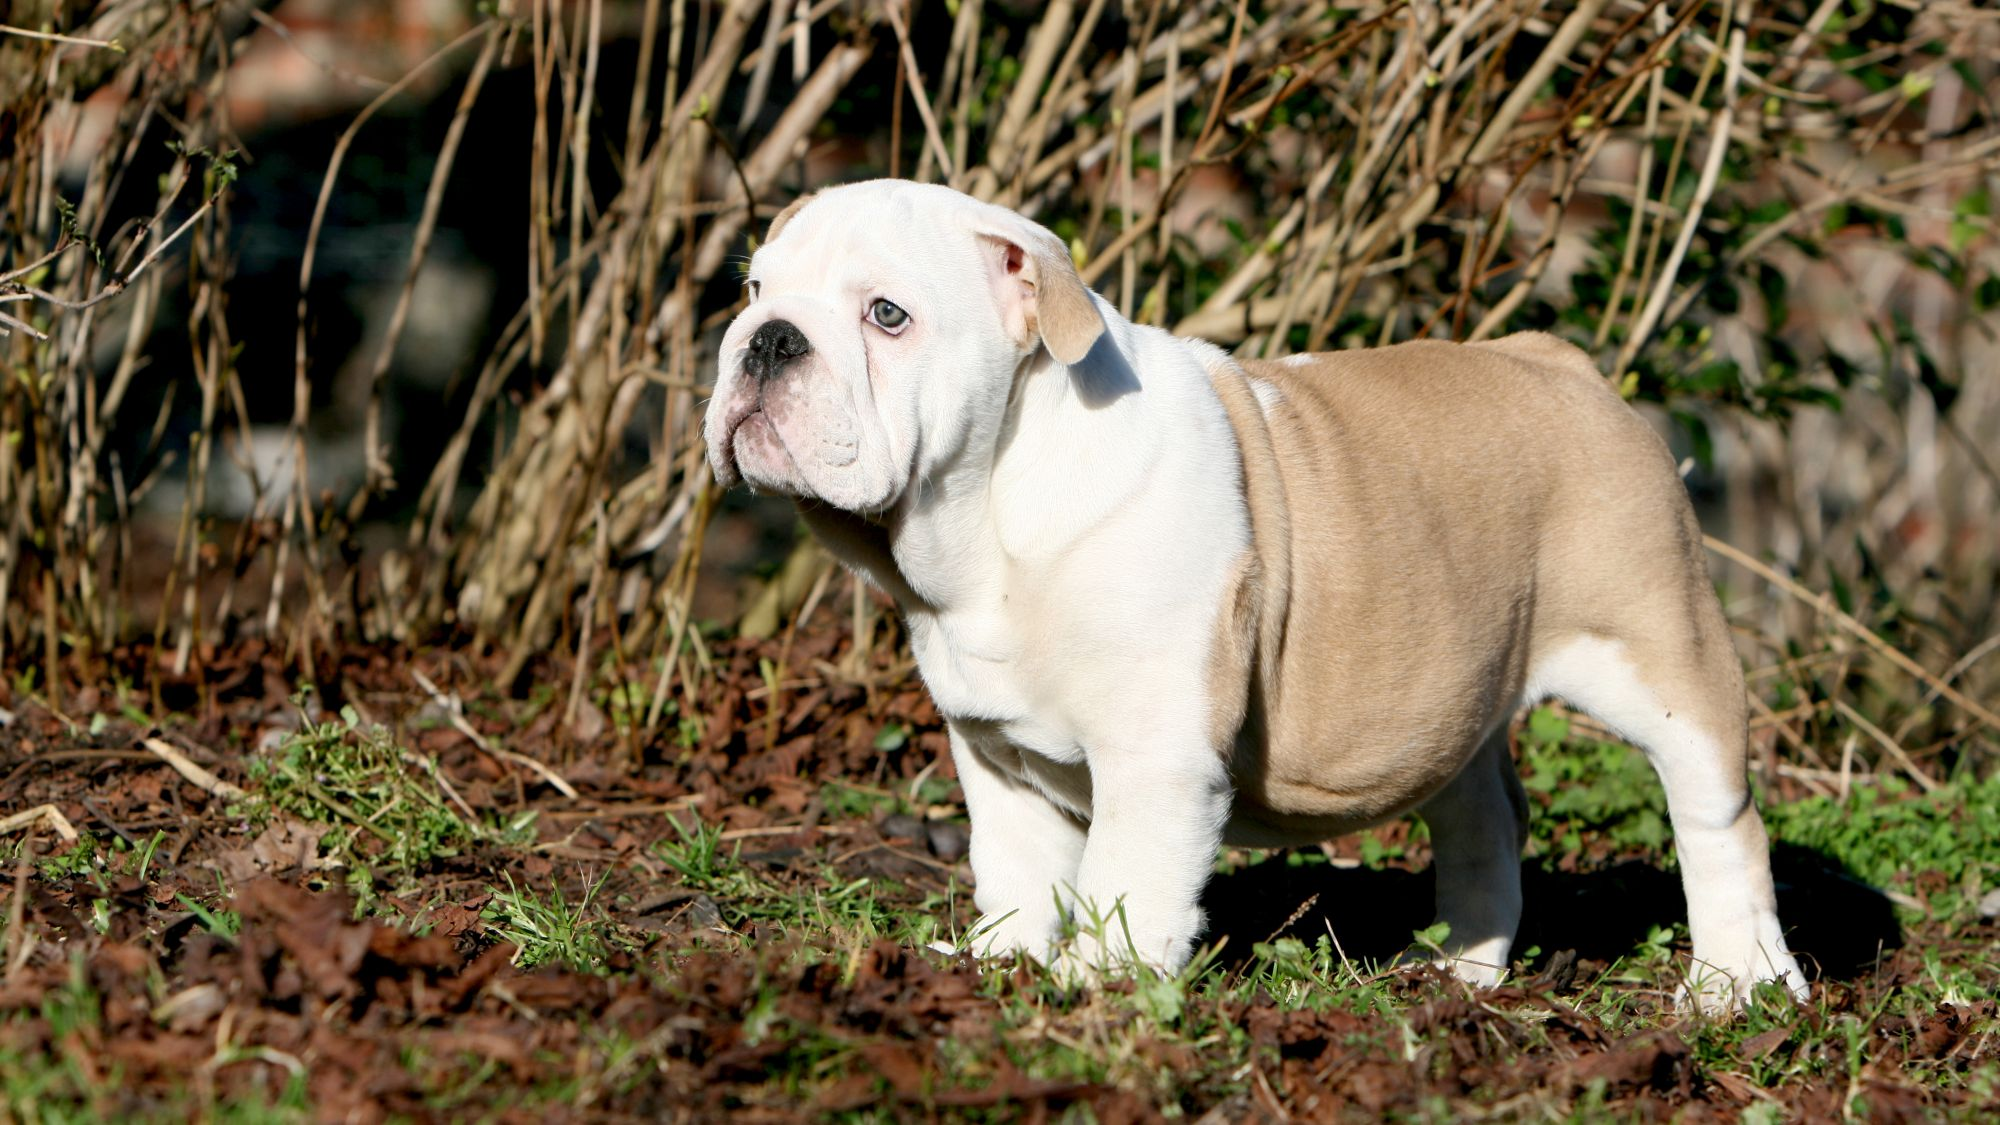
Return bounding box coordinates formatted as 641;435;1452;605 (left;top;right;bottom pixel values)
0;624;2000;1121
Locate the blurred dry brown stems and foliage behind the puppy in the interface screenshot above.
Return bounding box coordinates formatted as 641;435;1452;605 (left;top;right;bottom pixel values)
0;0;2000;793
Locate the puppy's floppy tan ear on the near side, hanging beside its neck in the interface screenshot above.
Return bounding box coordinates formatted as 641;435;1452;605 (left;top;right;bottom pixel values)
974;216;1104;366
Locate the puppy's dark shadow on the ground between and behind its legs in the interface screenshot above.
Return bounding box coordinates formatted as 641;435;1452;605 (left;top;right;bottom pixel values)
1202;845;1902;981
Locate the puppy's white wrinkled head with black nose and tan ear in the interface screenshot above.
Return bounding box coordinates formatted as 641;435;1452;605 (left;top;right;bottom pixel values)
704;180;1104;514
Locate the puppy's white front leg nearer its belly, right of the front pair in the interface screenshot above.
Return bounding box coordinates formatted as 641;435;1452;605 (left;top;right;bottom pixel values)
1074;745;1232;973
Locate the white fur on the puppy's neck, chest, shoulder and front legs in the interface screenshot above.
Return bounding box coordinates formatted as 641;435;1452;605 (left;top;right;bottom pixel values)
912;310;1248;965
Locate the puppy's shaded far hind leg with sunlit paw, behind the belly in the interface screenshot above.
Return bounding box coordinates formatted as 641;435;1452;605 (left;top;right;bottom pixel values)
1418;725;1528;987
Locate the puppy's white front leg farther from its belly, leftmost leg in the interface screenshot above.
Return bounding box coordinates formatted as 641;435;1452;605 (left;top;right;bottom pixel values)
950;723;1084;959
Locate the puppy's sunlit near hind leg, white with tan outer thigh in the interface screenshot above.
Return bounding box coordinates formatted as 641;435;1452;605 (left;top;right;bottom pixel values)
1528;632;1806;1011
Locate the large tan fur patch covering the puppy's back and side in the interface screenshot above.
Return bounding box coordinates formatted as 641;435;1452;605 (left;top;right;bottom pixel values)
1210;328;1742;839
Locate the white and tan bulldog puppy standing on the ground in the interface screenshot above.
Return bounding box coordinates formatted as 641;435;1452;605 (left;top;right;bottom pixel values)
706;180;1806;1009
